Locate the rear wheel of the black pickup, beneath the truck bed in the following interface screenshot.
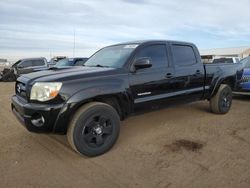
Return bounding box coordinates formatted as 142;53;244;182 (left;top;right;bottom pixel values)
210;84;233;114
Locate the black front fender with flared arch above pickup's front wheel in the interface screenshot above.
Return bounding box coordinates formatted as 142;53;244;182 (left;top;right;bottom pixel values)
54;78;129;133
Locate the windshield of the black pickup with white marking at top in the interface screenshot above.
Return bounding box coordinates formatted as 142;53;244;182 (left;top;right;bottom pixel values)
84;44;138;68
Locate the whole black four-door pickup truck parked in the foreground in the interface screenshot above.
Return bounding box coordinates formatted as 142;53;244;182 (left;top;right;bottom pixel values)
11;41;241;156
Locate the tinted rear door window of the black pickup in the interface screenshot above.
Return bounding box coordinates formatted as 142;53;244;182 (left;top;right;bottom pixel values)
172;45;196;66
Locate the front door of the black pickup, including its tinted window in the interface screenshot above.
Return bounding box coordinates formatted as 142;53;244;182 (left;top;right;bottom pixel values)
129;43;174;104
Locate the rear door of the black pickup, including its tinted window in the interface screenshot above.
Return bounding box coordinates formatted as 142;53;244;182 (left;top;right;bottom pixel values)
170;42;205;100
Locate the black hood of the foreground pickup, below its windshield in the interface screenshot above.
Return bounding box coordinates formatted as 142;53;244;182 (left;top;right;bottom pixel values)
22;66;120;83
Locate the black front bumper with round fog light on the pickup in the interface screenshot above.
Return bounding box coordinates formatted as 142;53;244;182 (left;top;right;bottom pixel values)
11;95;63;133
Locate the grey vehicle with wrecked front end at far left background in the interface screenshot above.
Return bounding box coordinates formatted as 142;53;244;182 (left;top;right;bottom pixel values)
0;57;48;81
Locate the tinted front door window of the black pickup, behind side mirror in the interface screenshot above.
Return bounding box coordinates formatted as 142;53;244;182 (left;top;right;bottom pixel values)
135;44;167;68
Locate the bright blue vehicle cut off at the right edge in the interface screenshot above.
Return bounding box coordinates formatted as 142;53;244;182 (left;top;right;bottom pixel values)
235;56;250;95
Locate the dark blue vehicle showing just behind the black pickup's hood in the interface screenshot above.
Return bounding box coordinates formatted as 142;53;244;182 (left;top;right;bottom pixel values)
55;57;88;67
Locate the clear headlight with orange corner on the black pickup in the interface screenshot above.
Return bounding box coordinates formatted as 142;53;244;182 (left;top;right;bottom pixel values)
30;82;62;101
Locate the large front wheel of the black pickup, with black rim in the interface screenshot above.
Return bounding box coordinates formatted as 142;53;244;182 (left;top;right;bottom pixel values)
67;102;120;157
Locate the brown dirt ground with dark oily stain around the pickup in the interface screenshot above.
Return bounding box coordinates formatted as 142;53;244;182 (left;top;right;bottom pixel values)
0;83;250;188
